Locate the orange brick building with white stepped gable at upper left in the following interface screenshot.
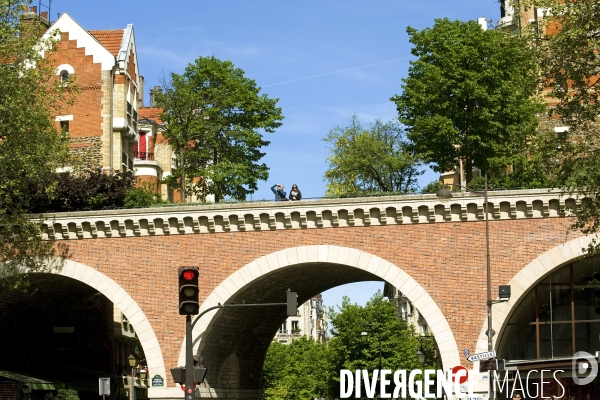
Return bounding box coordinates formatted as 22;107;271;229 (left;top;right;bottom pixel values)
38;11;143;171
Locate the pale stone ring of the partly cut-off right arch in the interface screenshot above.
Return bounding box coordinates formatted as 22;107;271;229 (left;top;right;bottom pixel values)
475;236;598;353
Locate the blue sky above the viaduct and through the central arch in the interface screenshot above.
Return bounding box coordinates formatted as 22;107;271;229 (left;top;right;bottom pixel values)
52;0;500;305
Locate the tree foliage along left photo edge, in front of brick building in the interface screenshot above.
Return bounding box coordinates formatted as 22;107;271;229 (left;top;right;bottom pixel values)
0;1;77;285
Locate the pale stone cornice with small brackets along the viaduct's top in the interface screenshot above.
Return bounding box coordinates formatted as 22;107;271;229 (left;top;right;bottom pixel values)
37;189;578;240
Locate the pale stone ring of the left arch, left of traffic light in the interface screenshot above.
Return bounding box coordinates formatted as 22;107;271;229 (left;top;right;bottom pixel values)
37;259;166;386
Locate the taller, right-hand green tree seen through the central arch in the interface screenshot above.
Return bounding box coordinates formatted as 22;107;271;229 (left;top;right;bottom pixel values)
328;292;428;397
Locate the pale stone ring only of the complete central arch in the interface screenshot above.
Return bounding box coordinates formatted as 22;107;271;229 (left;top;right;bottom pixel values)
178;245;460;376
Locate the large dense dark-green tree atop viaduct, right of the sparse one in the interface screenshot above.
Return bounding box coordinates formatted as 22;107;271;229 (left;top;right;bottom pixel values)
392;19;543;183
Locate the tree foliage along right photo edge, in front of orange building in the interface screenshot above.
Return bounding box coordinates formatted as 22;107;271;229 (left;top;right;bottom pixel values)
515;0;600;253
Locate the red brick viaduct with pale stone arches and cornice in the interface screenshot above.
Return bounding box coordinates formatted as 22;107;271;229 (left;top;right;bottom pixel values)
29;190;590;398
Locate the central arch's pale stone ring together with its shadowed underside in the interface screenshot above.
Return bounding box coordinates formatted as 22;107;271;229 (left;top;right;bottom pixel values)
188;245;460;398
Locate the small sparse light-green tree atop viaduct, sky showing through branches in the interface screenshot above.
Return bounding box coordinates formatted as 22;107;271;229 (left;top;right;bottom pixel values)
324;115;422;196
